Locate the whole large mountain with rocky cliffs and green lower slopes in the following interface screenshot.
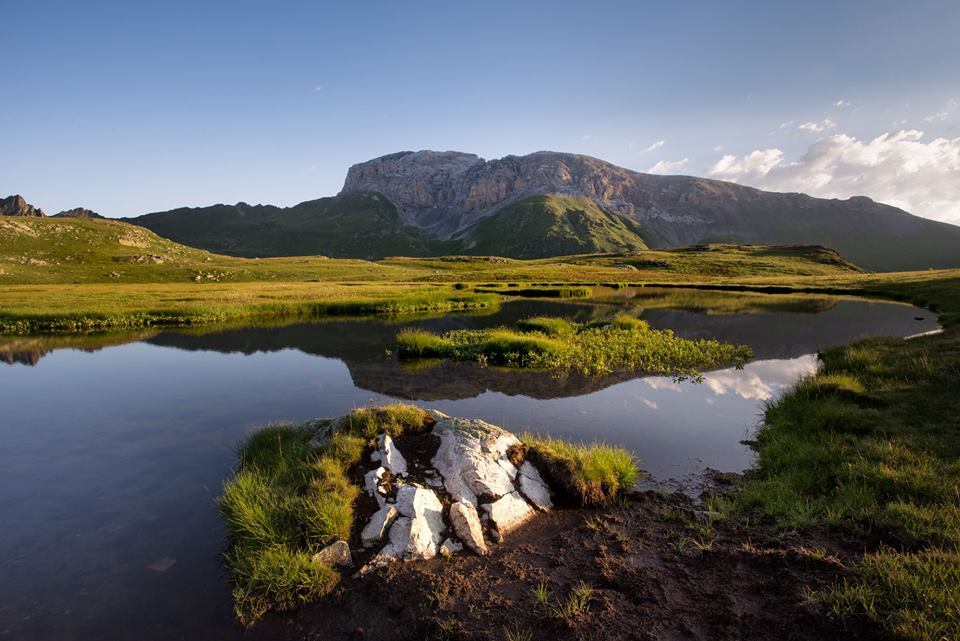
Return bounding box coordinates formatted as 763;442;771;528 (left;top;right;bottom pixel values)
126;151;960;270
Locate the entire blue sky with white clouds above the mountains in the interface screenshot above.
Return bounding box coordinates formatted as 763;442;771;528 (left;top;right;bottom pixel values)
0;0;960;222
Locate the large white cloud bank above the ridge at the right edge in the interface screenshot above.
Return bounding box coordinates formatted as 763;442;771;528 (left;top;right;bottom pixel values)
707;129;960;223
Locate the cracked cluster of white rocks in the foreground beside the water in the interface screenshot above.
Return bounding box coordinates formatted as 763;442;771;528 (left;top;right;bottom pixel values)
310;411;553;574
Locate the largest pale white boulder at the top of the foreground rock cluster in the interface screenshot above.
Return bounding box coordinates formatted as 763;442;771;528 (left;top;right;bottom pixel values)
433;418;520;505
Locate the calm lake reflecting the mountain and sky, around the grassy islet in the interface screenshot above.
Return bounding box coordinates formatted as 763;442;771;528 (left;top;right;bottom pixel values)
0;288;937;641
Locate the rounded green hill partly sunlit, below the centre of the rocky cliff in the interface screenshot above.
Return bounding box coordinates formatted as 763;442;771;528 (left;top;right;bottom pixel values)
463;195;647;258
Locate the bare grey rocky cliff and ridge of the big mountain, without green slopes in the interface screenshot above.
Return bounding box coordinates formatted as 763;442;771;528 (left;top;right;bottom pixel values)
341;151;960;269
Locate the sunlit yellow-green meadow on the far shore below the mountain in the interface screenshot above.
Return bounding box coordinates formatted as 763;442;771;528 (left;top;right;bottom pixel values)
0;217;872;334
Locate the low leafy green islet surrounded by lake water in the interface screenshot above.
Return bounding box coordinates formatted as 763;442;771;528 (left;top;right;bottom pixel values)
397;314;752;377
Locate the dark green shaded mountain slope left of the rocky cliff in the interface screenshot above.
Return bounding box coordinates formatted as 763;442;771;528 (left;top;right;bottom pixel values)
124;194;442;258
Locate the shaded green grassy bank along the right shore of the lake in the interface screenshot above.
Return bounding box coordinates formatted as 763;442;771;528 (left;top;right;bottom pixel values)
728;280;960;641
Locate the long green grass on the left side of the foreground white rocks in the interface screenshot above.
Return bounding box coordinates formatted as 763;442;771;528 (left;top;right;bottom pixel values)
219;404;430;625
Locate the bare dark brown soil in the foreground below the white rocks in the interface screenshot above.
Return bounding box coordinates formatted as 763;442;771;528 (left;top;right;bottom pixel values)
248;492;878;641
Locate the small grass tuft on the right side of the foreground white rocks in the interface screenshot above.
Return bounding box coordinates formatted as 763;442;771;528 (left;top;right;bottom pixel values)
520;433;640;505
